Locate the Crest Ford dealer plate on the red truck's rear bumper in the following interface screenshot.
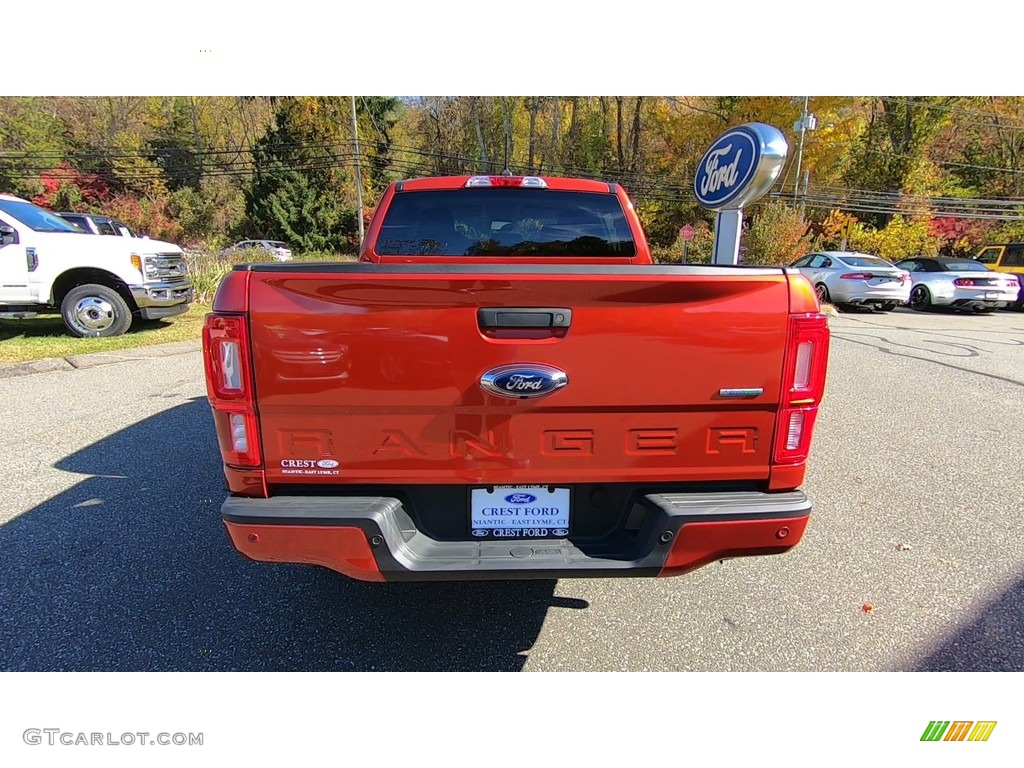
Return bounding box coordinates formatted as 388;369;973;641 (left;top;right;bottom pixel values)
469;485;571;541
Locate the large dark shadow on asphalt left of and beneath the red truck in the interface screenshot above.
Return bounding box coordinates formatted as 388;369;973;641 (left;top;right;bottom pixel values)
0;399;588;671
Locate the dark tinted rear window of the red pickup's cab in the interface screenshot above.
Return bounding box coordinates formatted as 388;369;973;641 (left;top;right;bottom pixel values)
376;187;636;257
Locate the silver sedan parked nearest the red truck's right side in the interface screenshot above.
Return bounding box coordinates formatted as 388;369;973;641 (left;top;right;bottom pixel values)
791;251;910;312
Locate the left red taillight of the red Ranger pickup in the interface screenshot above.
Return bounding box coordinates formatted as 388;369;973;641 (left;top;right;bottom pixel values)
203;312;260;467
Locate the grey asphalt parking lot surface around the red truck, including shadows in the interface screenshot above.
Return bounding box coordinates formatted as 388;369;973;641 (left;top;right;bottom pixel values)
0;309;1024;671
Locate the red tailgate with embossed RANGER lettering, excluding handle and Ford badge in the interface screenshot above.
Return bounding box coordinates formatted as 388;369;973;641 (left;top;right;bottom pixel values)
249;264;788;485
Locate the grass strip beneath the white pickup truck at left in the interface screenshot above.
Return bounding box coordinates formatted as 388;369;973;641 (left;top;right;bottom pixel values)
0;304;210;362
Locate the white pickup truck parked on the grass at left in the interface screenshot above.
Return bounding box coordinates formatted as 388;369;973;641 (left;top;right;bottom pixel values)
0;195;193;336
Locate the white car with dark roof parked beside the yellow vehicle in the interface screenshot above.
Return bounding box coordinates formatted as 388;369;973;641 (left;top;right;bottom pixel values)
896;256;1020;312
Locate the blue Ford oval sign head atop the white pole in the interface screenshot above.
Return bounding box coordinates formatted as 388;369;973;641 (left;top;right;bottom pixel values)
693;123;790;211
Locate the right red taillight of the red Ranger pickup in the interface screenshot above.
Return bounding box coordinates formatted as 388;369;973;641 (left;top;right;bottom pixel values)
773;312;828;464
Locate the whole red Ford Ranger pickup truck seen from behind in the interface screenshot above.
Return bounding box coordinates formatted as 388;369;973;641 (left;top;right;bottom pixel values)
204;175;829;582
